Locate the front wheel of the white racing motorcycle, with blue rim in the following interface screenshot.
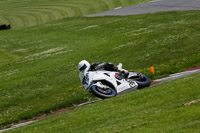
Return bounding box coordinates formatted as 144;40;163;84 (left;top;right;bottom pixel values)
90;85;117;99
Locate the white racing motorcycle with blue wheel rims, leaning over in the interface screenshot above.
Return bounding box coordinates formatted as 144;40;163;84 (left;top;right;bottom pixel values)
82;63;151;99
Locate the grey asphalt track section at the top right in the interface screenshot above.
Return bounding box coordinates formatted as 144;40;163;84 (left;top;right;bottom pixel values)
88;0;200;17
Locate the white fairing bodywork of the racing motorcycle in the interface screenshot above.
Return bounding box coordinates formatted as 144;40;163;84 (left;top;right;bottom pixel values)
84;70;138;94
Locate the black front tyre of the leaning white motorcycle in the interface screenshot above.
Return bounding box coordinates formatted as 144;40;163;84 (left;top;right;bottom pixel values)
90;86;117;99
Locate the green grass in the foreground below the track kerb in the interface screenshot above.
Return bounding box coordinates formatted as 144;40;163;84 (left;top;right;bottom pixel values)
5;70;200;133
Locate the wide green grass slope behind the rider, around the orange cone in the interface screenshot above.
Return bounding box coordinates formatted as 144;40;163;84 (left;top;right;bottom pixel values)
0;11;200;127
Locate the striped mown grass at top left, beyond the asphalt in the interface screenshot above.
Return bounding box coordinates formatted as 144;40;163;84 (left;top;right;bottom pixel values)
0;0;150;28
